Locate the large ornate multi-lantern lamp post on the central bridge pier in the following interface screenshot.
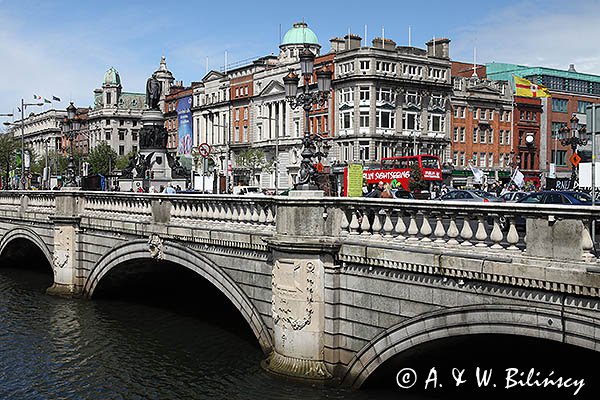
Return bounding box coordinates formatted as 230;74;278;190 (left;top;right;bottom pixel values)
283;47;332;190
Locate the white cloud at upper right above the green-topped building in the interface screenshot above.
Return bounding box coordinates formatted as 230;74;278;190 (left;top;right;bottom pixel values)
451;1;600;74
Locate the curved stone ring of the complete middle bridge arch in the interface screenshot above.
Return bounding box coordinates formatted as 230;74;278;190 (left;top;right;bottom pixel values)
82;240;272;354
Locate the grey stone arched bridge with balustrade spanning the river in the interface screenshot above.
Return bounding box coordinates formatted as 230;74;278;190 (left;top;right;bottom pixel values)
0;191;600;387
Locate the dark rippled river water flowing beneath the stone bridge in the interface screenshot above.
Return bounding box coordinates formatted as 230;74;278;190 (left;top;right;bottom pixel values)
0;260;598;400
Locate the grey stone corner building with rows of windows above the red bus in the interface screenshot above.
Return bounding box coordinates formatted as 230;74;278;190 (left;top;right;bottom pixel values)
332;34;452;165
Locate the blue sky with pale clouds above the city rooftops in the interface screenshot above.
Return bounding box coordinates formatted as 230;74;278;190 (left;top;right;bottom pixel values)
0;0;600;120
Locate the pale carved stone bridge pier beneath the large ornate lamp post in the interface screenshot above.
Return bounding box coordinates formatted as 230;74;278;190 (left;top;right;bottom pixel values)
264;200;339;380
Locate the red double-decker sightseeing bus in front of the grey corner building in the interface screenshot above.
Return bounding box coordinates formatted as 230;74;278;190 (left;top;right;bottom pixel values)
363;154;442;190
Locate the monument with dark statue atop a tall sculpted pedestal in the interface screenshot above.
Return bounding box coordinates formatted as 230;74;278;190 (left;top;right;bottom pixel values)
119;73;189;192
